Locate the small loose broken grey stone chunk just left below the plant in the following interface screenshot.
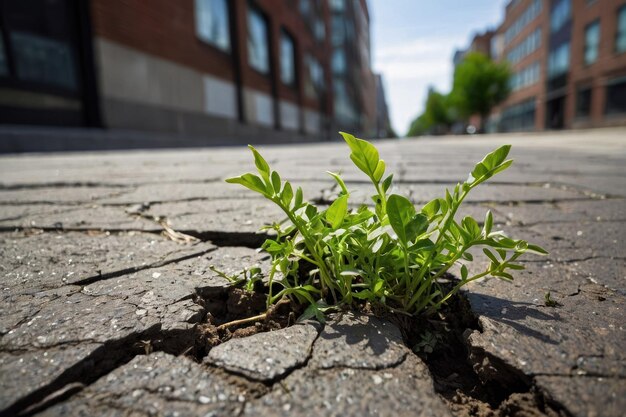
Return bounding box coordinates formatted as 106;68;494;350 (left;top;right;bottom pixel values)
205;324;319;381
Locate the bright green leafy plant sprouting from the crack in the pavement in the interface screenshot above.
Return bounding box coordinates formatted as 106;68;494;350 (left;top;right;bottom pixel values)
226;133;546;320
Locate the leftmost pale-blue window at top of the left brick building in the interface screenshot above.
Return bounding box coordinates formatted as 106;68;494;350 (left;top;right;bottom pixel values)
196;0;230;52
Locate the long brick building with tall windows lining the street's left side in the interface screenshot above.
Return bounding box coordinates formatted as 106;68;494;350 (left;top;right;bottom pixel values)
0;0;386;142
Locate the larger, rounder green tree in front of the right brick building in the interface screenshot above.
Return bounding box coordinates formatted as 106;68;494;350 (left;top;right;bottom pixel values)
451;52;511;130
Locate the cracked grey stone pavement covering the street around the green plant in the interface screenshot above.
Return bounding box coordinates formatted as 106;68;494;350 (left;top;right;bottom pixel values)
0;129;626;417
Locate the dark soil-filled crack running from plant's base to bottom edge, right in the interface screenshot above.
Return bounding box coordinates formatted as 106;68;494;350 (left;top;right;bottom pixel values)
388;294;567;417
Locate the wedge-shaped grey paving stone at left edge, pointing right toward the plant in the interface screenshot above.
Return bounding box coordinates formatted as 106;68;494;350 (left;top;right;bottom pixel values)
0;232;215;297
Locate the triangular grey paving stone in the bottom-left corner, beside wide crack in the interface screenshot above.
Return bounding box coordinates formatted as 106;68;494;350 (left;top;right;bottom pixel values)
0;343;102;413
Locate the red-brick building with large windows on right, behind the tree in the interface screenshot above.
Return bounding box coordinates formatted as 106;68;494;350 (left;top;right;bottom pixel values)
458;0;626;131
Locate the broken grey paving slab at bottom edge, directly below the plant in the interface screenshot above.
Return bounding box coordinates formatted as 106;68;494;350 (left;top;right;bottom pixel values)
243;352;450;417
